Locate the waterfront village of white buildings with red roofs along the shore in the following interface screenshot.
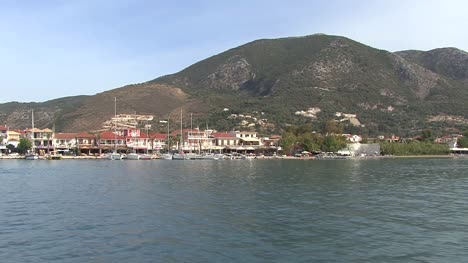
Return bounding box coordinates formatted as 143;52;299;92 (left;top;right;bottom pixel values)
0;114;468;159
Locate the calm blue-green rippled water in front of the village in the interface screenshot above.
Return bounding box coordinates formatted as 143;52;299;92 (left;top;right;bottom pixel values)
0;159;468;262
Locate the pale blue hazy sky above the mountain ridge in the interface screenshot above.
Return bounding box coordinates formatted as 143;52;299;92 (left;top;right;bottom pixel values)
0;0;468;102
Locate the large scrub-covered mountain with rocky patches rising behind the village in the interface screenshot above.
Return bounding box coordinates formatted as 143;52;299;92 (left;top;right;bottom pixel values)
0;34;468;136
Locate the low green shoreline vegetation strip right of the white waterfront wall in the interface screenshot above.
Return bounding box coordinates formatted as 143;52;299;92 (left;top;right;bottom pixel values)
380;141;450;156
